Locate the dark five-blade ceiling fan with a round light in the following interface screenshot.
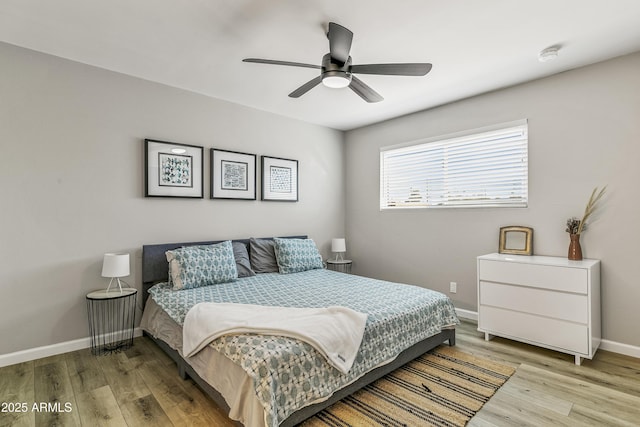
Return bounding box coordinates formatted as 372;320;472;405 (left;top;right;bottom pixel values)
242;22;431;102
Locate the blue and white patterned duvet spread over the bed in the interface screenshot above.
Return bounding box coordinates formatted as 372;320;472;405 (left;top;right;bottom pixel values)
149;269;458;427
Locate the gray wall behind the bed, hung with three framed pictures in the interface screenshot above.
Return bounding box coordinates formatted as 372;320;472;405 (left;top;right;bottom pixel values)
0;43;344;354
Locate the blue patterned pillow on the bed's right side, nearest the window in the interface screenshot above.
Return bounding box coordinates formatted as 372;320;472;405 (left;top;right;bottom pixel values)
273;237;323;274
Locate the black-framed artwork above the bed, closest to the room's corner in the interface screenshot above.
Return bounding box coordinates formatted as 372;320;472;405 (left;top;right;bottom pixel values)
261;156;298;202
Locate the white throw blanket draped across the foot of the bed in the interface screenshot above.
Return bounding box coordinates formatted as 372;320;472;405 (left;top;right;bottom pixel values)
182;302;367;374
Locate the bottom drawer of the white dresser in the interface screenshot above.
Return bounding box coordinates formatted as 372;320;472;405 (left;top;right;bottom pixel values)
478;307;589;355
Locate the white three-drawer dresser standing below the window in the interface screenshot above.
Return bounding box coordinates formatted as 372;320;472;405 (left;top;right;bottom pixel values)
478;254;602;365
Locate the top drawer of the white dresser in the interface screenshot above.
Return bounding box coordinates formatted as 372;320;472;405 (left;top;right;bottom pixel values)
478;260;588;295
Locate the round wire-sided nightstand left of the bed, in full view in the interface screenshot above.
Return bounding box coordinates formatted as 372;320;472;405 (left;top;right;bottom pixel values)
87;288;138;355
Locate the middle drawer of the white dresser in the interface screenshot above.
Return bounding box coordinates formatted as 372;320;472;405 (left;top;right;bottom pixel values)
480;281;589;324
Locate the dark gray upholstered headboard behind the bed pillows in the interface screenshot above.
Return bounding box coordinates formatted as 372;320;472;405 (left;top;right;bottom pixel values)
142;236;307;301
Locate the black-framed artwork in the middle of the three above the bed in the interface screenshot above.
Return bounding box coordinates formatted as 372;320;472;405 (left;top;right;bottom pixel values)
211;148;256;200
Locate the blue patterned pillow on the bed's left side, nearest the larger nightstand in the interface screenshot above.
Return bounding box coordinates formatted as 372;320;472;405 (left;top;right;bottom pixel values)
166;240;238;291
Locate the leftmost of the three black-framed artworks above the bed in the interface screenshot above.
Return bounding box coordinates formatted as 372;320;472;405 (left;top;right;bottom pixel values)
144;139;204;199
